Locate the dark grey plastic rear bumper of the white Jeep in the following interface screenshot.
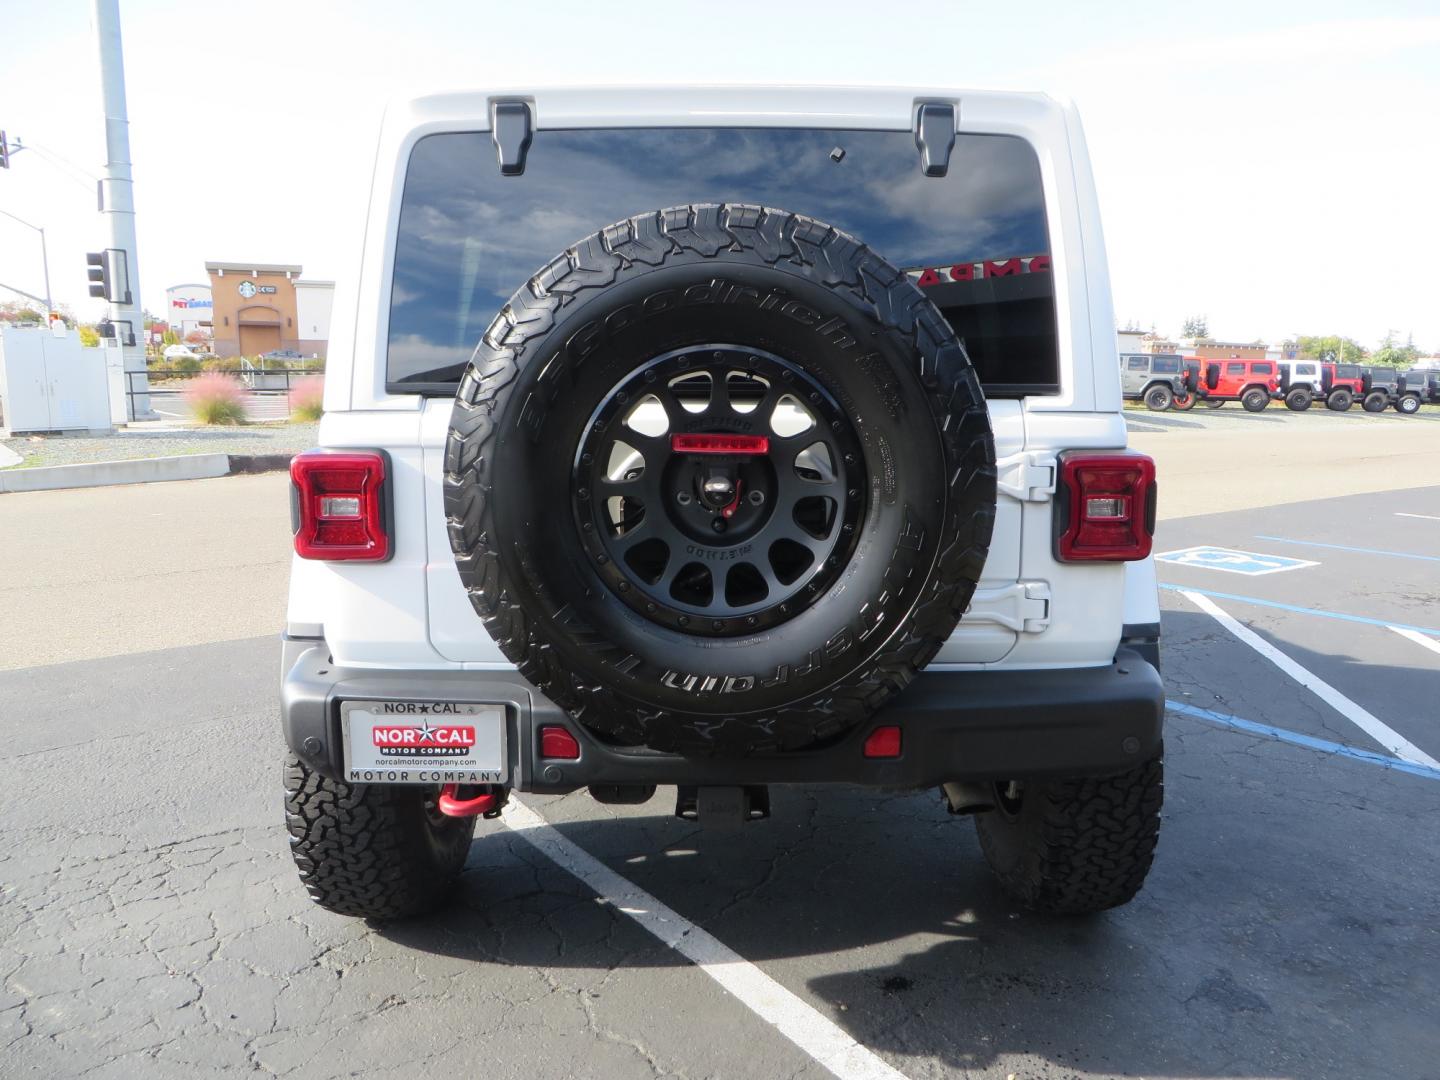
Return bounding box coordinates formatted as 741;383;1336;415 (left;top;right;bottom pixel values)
281;638;1165;793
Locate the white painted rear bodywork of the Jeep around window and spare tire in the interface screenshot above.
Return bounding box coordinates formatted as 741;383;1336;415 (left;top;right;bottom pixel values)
288;88;1159;668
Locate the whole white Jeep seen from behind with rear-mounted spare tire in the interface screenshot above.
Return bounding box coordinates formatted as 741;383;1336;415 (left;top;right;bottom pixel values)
282;88;1164;917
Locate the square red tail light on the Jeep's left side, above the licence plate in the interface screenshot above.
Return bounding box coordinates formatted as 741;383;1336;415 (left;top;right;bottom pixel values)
289;449;390;562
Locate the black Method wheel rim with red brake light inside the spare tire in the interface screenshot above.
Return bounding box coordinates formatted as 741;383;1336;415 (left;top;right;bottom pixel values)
572;344;868;636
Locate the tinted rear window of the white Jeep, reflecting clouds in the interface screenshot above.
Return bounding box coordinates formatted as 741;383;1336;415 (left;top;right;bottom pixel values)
386;128;1060;396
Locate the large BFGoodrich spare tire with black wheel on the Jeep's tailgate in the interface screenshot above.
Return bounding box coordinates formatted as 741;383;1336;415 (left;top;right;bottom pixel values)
445;204;995;755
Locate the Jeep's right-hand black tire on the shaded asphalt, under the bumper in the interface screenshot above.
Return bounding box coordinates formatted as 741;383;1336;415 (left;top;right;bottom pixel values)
975;756;1165;914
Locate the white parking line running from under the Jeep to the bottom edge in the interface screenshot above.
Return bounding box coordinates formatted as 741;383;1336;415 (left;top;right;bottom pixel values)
500;798;906;1080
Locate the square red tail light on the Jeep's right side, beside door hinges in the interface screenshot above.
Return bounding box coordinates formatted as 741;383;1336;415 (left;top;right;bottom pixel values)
1056;452;1155;563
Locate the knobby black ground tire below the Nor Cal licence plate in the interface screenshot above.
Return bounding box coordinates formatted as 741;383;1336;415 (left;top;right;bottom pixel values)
284;755;475;919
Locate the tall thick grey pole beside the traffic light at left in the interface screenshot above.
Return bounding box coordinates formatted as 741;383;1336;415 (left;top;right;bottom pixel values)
94;0;154;420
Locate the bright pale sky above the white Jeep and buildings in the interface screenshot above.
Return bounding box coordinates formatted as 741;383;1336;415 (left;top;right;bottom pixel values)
0;0;1440;351
